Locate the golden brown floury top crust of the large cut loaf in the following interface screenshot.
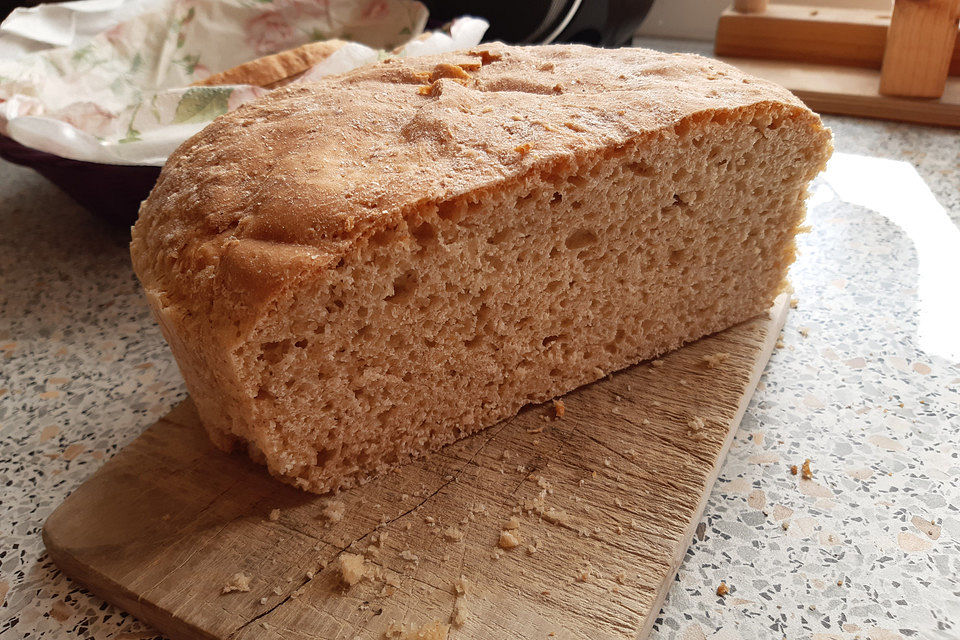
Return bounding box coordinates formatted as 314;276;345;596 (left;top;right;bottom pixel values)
131;44;821;332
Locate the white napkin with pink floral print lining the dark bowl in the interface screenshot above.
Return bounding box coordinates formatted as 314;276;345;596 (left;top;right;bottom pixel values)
0;0;487;166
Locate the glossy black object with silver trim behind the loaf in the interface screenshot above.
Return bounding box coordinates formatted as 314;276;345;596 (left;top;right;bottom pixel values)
421;0;653;47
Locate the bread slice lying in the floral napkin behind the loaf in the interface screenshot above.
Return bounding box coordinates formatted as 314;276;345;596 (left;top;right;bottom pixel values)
194;40;347;89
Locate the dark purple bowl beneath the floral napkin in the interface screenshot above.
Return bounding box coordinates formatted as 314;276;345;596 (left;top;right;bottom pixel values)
0;136;160;227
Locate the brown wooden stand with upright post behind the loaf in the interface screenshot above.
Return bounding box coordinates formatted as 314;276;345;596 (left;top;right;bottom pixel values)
715;0;960;127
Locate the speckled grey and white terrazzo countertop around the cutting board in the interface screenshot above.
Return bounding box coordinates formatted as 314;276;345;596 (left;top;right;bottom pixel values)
0;45;960;640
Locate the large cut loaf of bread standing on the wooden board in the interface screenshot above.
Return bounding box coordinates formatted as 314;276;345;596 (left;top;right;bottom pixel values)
131;45;831;492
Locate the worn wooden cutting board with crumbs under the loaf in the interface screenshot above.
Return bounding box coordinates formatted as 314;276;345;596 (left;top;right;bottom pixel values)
43;297;787;640
